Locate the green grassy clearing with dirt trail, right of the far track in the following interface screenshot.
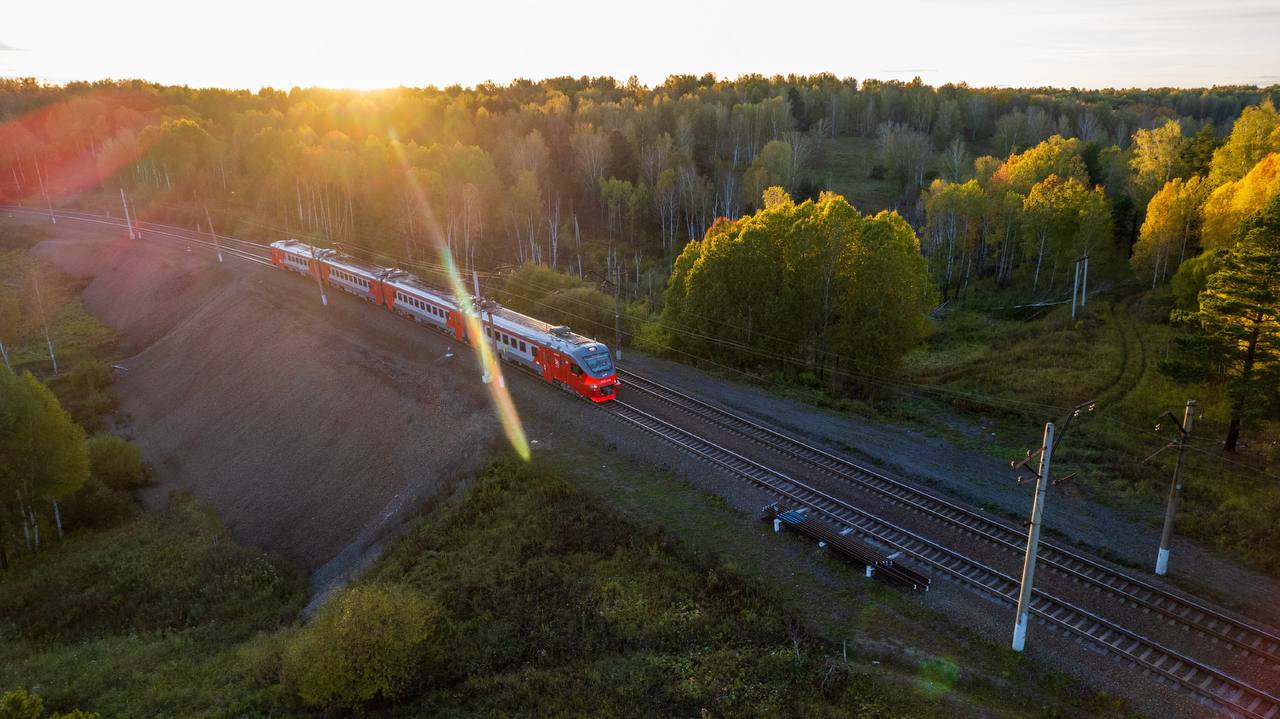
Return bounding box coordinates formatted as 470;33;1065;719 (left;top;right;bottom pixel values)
902;288;1280;576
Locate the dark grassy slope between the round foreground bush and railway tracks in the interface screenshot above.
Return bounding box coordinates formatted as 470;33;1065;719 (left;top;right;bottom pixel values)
358;449;1121;716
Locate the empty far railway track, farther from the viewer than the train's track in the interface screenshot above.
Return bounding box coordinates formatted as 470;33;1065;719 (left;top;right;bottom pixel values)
618;370;1280;667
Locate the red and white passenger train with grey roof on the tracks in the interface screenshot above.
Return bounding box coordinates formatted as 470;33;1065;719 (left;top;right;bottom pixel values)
271;239;618;402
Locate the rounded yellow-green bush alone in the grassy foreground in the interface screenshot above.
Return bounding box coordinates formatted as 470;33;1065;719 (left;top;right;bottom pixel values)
280;585;443;707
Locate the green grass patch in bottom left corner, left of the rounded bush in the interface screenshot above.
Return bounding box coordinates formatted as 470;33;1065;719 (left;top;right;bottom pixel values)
0;491;306;716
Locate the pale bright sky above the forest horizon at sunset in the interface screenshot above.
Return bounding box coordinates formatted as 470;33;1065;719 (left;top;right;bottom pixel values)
0;0;1280;90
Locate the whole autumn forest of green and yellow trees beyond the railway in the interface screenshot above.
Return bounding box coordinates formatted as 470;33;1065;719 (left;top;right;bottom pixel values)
0;74;1280;446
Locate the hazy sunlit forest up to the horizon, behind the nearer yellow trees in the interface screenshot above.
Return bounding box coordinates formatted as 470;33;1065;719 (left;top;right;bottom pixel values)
0;74;1274;289
